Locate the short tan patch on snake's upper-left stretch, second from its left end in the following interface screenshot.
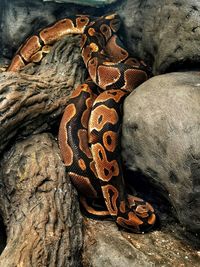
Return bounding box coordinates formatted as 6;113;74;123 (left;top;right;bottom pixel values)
20;35;42;62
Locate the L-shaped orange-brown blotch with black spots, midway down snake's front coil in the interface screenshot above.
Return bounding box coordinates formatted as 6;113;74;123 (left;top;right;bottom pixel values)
91;143;119;182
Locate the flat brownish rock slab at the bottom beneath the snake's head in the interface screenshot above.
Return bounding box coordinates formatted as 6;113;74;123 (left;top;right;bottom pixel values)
83;220;200;267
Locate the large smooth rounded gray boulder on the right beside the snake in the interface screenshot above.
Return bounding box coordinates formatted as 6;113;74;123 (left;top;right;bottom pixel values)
122;72;200;232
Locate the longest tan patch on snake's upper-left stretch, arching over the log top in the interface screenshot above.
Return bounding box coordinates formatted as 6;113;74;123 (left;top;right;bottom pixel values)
39;19;80;44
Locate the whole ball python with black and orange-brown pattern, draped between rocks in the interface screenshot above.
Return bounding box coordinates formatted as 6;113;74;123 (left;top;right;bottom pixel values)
7;14;156;233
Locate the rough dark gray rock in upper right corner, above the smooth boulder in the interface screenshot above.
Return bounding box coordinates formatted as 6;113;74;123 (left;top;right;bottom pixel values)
118;0;200;74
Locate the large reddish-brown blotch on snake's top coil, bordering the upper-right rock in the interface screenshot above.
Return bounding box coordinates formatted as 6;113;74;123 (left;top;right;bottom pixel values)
105;35;128;63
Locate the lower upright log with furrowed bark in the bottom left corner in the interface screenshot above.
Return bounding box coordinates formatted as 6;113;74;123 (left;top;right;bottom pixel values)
0;133;83;267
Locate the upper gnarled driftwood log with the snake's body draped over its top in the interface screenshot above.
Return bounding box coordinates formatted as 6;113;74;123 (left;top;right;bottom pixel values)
0;37;85;157
